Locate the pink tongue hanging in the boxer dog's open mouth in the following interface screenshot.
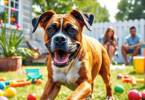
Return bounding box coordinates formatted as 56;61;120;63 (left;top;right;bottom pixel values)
54;54;69;64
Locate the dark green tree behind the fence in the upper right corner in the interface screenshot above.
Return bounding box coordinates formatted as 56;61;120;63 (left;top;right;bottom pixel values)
115;0;145;21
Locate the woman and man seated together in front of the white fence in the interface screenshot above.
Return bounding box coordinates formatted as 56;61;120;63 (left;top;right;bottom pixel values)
101;26;142;65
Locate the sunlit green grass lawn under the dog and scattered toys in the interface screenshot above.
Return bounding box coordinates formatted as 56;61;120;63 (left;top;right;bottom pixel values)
0;66;145;100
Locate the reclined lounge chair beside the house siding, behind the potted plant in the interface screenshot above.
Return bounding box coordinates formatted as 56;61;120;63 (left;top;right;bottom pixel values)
26;40;49;65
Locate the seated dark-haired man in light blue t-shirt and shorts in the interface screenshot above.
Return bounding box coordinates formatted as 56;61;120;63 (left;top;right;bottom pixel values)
121;26;142;65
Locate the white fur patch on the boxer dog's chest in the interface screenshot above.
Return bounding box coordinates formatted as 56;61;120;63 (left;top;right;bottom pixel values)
52;58;82;90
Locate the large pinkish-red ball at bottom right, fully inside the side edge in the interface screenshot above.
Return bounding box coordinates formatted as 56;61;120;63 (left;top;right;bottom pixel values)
128;90;141;100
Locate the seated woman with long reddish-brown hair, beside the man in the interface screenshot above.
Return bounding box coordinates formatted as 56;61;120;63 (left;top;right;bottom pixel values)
101;26;118;62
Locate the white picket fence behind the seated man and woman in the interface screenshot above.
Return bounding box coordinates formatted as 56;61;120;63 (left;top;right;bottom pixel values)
83;19;145;62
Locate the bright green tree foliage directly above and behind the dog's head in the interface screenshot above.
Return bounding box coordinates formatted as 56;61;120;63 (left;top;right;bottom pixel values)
33;0;109;22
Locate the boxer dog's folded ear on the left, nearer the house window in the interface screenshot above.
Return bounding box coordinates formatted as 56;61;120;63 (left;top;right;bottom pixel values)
32;10;55;33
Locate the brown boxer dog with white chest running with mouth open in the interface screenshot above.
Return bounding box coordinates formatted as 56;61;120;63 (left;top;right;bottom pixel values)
32;10;113;100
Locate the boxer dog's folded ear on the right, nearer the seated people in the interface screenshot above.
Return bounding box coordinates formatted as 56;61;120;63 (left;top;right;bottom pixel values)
70;10;94;31
